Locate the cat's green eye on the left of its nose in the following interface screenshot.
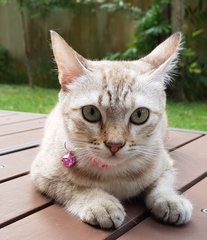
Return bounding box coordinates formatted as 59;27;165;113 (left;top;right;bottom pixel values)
82;105;101;123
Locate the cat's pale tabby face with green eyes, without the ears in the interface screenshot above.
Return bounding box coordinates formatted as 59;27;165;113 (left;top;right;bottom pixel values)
63;62;165;167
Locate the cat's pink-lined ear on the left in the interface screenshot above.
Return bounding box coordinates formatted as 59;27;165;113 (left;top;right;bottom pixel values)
50;31;86;90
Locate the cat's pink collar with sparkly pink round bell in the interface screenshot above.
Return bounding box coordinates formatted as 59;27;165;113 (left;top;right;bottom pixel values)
62;151;111;169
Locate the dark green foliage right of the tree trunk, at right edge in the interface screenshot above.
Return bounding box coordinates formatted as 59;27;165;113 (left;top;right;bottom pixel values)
180;0;207;100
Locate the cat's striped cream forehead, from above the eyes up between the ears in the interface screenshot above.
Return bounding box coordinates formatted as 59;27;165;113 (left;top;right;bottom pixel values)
68;61;164;111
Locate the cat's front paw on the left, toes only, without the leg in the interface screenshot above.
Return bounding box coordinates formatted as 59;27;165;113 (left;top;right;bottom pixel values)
80;197;126;228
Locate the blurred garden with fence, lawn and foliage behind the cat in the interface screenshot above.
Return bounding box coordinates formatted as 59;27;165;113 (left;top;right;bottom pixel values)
0;0;207;130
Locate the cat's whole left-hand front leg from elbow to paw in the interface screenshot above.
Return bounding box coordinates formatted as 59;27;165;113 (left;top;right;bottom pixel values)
31;167;126;228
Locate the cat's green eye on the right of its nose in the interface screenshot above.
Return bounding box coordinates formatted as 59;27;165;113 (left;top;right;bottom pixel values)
130;107;149;125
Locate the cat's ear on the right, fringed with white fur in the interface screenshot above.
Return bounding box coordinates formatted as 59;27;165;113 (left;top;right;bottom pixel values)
140;32;182;84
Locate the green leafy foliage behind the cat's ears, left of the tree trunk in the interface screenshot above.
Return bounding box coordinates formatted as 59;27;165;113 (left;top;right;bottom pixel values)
106;0;171;60
